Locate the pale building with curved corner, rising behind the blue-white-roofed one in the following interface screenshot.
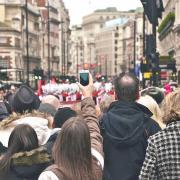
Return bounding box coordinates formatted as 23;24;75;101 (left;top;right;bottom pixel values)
82;7;134;71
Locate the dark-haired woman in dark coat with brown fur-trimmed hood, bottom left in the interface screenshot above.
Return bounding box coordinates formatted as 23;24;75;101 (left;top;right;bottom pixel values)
0;124;51;180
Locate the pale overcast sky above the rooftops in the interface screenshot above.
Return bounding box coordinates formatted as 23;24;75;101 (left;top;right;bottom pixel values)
64;0;141;25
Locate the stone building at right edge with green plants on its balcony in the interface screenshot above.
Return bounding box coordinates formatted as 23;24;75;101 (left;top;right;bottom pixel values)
157;0;180;82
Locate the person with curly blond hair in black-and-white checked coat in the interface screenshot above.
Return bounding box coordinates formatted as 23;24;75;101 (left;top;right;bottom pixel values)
139;89;180;180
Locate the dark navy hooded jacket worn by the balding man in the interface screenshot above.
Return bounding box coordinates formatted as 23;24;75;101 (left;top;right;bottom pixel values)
101;101;160;180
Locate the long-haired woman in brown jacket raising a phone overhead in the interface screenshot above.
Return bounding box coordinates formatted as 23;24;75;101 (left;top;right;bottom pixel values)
39;75;104;180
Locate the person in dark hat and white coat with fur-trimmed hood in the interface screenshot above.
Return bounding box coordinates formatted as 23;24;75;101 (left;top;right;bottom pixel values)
0;85;51;148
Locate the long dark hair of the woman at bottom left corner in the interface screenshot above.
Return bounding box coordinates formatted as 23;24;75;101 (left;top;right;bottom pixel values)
0;124;38;171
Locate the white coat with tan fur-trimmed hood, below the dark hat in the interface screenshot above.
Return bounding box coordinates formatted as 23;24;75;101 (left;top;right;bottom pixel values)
0;111;51;147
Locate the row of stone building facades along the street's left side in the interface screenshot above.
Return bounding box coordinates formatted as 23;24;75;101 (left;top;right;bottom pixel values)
0;0;70;81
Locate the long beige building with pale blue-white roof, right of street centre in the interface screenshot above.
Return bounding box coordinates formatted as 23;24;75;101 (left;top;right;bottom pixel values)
95;8;143;76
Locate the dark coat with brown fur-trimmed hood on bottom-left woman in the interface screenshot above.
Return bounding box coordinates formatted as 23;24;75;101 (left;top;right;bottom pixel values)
0;147;51;180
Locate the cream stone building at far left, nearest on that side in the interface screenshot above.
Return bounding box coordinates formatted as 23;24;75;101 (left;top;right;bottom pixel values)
0;0;40;80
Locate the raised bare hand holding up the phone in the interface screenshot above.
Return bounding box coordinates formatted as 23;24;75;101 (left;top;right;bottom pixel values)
77;73;94;98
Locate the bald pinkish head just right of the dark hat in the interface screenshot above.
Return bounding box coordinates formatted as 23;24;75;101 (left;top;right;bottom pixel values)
41;95;60;109
